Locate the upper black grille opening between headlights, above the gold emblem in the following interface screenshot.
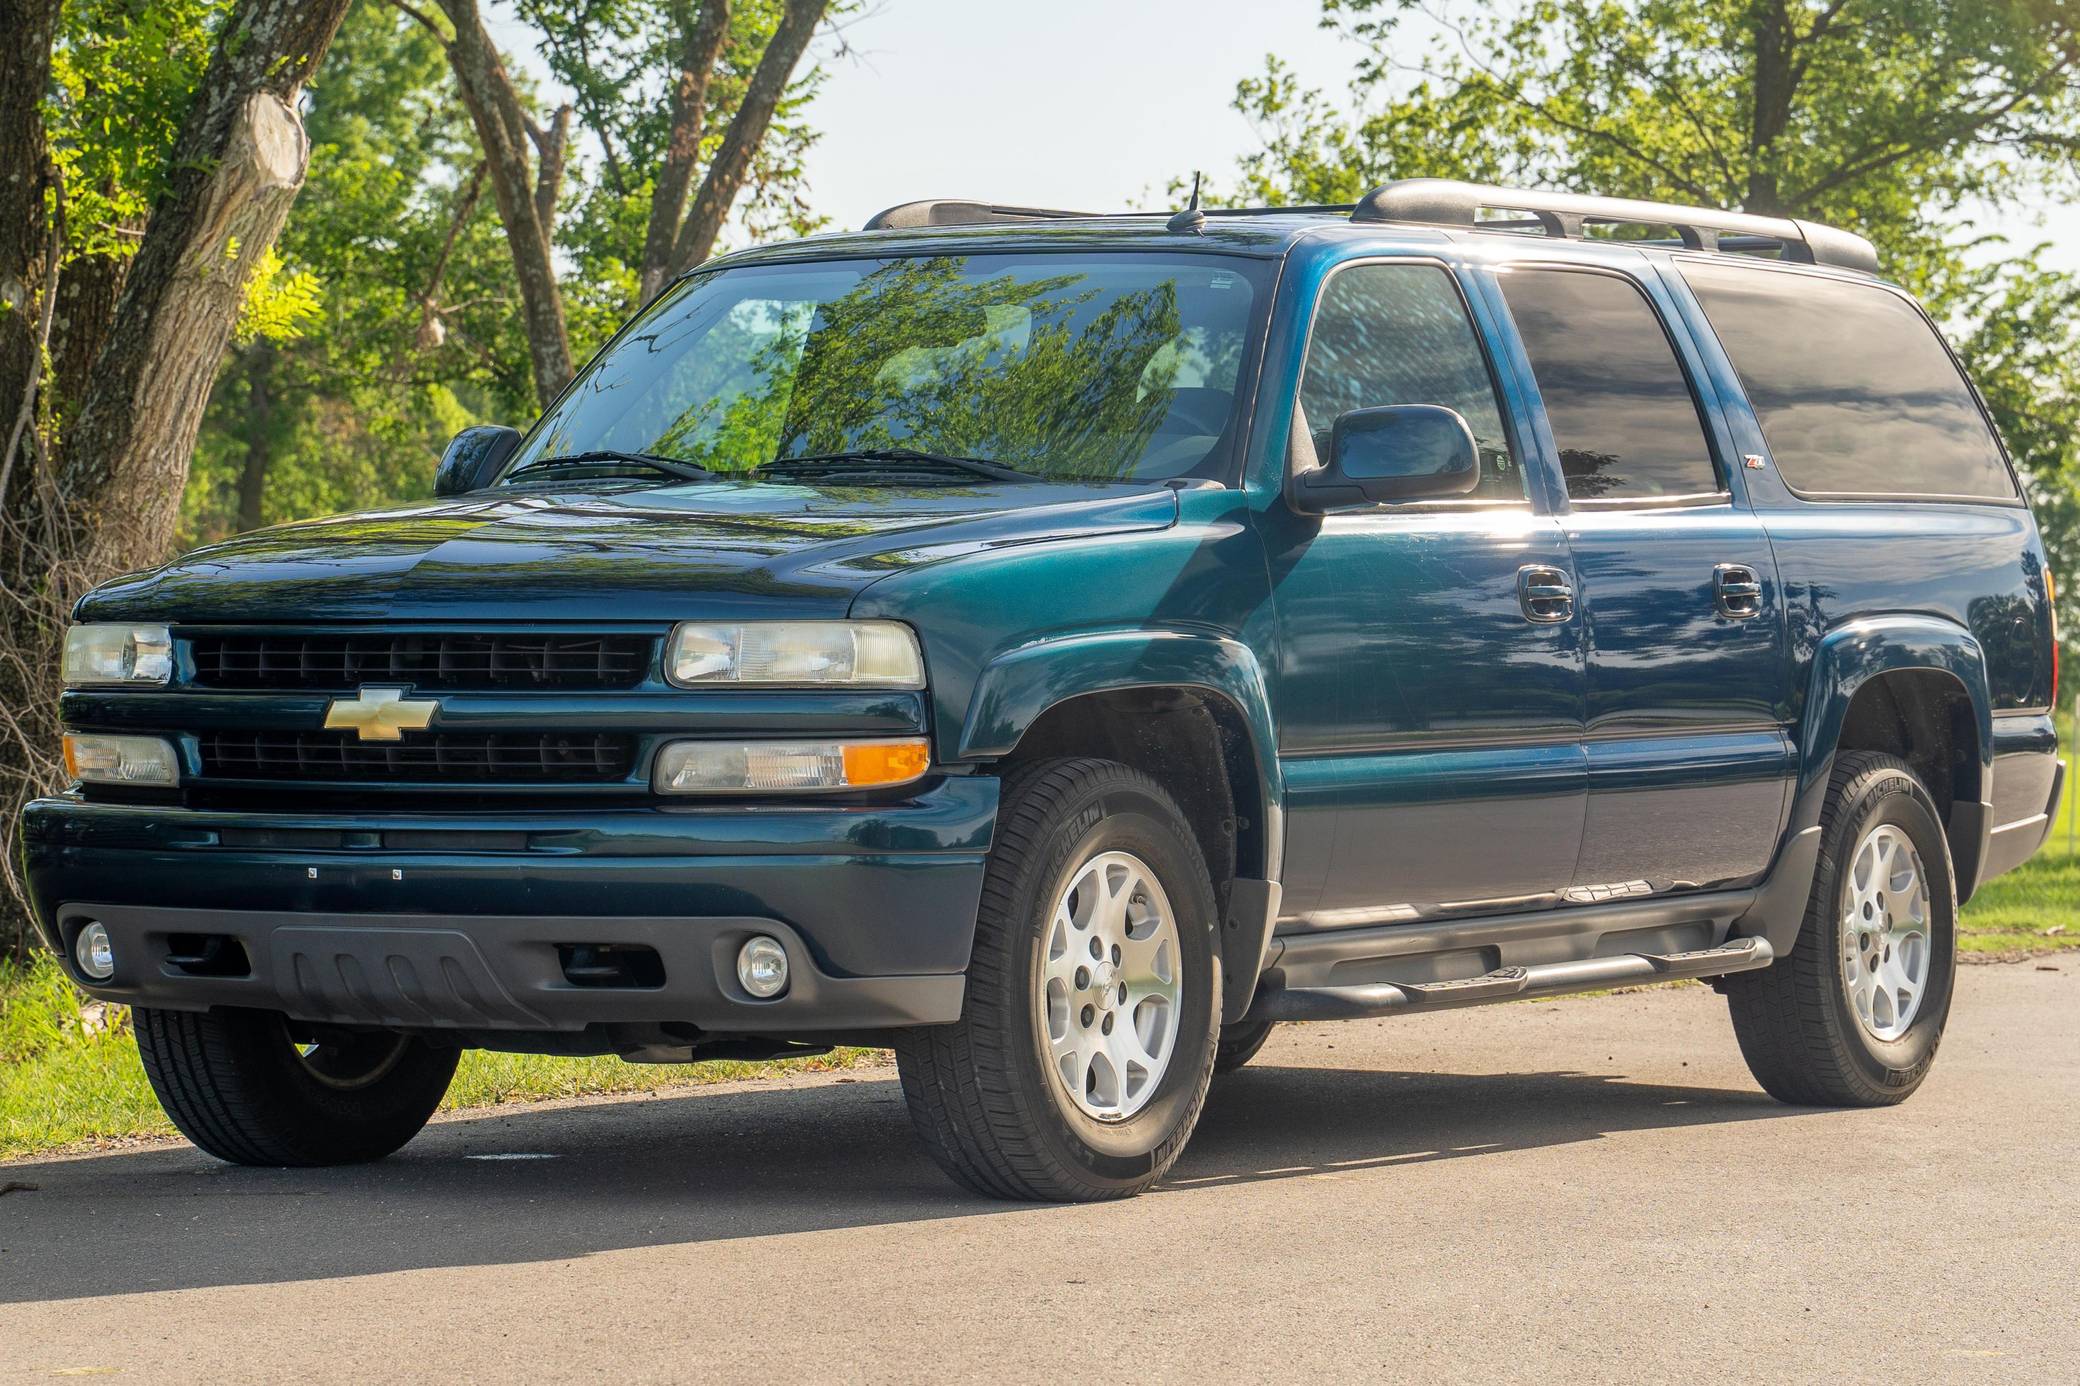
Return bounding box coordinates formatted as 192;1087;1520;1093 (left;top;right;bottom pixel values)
187;631;653;693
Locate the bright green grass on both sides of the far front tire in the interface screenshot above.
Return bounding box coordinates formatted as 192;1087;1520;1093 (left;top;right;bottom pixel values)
0;955;876;1159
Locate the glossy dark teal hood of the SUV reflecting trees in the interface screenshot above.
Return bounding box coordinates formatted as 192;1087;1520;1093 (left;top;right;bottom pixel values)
77;483;1177;624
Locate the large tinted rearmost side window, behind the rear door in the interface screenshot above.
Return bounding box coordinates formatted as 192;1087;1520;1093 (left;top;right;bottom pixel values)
1683;262;2016;499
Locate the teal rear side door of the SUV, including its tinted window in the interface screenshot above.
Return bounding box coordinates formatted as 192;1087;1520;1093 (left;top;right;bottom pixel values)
1493;260;1793;901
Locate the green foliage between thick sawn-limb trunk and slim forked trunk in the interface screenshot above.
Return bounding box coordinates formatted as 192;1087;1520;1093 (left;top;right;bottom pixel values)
183;4;532;541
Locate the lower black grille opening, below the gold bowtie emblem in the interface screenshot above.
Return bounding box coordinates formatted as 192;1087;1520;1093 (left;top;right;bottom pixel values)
202;730;636;785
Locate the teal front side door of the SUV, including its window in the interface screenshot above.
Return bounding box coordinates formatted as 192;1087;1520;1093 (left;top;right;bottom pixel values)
1267;260;1587;932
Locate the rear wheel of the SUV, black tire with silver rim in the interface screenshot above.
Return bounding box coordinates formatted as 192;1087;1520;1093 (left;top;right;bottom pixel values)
1726;751;1957;1107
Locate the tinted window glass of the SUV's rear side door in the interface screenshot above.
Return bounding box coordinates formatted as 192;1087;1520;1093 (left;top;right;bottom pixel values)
1500;266;1722;502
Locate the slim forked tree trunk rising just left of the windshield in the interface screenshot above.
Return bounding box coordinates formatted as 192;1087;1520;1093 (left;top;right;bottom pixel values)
439;0;572;406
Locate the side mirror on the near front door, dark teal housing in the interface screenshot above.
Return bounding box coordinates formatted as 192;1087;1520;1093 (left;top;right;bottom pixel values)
1285;404;1481;514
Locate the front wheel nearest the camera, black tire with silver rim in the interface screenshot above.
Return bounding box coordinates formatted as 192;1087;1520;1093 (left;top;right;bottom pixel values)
896;760;1219;1203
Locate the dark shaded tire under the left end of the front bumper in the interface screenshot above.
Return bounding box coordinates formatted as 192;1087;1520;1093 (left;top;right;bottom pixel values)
135;1009;462;1165
